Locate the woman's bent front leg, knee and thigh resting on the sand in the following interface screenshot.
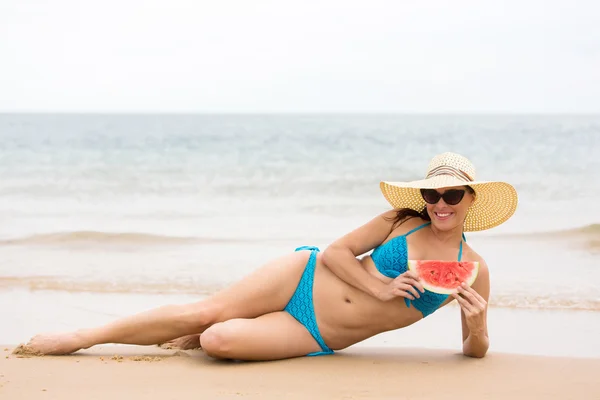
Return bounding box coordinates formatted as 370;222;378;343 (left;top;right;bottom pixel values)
200;311;321;361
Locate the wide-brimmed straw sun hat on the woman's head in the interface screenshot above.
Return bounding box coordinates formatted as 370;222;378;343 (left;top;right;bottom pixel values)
379;152;517;232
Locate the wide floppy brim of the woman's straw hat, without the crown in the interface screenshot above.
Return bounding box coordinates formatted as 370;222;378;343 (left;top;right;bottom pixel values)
379;175;518;232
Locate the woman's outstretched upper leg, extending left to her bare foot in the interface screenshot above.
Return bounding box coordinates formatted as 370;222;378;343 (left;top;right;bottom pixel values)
28;251;310;354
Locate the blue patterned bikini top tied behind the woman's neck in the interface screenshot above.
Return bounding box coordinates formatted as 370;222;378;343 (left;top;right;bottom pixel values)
371;222;465;317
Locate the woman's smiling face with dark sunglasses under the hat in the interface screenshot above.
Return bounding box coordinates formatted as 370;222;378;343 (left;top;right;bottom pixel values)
421;186;475;231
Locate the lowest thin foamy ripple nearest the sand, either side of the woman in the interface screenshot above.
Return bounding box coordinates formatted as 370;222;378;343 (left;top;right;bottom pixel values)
0;276;600;312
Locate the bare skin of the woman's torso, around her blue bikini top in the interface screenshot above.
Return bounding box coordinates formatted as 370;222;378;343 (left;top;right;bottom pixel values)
313;218;470;349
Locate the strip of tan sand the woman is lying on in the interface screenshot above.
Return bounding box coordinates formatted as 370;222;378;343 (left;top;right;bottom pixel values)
0;346;600;400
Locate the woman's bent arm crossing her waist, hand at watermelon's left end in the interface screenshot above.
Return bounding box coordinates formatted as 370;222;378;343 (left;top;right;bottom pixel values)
323;210;422;301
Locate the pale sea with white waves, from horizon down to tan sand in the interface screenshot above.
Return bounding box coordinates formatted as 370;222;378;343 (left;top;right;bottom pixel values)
0;113;600;357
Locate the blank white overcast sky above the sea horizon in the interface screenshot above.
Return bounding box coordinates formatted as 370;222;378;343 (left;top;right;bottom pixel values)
0;0;600;113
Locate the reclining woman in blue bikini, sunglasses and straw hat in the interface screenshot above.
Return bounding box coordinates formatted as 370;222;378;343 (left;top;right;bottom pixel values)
28;153;517;360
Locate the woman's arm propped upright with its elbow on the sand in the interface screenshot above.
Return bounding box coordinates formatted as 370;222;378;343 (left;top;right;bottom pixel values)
453;260;490;358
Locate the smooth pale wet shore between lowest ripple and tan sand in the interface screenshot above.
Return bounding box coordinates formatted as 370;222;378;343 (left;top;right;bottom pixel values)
0;291;600;358
